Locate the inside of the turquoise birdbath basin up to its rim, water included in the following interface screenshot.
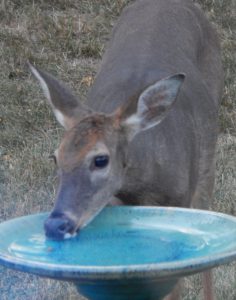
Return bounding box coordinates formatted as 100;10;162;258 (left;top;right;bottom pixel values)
0;207;236;267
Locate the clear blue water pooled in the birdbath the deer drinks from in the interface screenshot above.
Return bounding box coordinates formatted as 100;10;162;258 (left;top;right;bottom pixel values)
8;224;212;266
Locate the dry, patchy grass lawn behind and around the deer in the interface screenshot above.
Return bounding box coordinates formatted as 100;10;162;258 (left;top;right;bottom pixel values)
0;0;236;300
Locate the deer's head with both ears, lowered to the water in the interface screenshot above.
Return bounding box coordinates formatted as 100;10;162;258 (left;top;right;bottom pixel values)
30;65;184;239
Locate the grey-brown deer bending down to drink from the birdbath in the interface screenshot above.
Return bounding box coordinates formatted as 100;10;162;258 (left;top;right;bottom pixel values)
30;0;222;300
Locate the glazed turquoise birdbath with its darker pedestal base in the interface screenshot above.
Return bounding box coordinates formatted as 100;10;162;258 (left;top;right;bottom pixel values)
0;206;236;300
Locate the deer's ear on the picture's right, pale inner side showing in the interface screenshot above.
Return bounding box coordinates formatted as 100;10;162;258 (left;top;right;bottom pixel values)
123;74;185;140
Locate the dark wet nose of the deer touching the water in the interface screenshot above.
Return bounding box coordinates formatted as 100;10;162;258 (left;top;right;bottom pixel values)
44;216;75;240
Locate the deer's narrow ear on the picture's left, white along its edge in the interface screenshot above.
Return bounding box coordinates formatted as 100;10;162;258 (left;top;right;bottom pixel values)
28;63;91;129
